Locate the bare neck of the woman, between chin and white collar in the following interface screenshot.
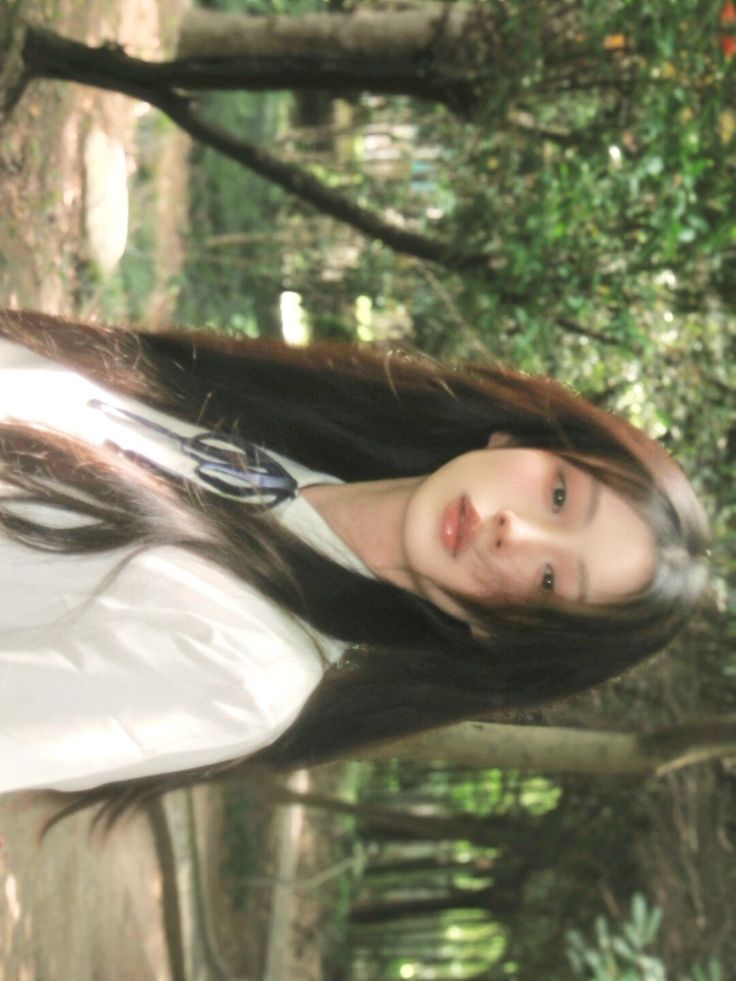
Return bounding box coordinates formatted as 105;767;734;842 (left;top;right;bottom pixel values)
300;477;423;589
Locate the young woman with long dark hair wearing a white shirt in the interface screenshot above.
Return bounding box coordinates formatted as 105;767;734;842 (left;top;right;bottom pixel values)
0;311;707;816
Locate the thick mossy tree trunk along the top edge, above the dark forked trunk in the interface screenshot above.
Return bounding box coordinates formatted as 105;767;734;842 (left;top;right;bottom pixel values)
177;3;493;113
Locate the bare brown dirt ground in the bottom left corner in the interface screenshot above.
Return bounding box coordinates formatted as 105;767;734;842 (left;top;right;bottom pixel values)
0;795;171;981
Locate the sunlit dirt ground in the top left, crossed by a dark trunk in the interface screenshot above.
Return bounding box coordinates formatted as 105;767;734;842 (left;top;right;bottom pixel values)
0;0;190;324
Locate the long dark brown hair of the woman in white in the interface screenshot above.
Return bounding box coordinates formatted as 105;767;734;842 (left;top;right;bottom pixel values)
0;311;708;819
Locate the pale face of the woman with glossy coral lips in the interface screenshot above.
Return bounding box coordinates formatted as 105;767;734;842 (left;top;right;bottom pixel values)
402;447;655;615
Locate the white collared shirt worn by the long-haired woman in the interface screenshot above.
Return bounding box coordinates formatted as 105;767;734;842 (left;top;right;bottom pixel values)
0;338;370;793
